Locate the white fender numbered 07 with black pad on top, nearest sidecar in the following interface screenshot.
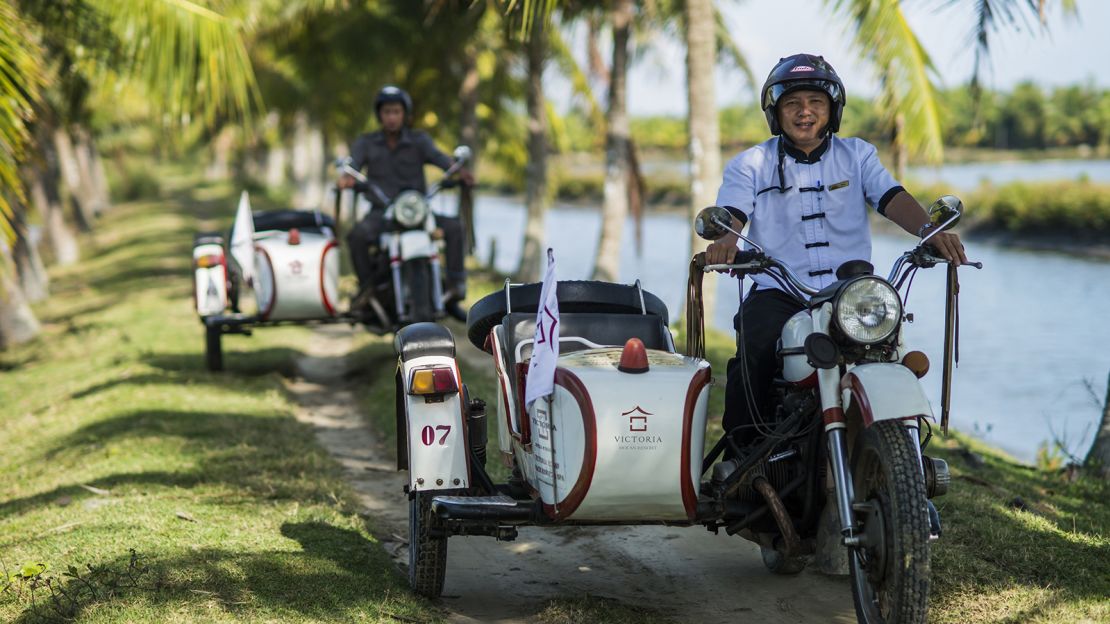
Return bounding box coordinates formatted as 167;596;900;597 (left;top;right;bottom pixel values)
394;323;470;491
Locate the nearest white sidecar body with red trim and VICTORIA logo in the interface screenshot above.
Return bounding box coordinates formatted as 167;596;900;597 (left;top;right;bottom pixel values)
396;282;709;524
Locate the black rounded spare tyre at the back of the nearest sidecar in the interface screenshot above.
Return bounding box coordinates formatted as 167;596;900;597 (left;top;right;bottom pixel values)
466;281;668;349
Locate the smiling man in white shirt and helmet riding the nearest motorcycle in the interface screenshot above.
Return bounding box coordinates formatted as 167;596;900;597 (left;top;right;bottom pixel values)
706;54;967;445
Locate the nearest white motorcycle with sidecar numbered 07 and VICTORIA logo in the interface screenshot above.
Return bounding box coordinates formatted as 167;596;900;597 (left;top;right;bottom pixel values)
394;197;981;623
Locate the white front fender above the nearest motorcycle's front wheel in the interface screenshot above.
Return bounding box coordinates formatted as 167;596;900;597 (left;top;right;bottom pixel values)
840;363;932;426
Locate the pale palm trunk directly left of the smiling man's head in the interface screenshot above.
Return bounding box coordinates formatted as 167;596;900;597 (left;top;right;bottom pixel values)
686;0;720;318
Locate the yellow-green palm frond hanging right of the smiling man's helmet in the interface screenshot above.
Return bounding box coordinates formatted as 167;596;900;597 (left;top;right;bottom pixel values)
826;0;944;162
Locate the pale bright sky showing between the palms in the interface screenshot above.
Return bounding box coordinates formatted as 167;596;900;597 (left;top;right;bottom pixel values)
586;0;1110;115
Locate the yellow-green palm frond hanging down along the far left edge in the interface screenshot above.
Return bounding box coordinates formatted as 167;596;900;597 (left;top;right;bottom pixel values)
0;0;44;243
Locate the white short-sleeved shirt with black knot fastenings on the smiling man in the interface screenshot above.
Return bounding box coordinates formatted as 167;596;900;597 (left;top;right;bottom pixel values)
717;134;904;289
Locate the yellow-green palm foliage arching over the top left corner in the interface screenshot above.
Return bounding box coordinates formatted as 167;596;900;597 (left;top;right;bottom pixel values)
0;0;274;344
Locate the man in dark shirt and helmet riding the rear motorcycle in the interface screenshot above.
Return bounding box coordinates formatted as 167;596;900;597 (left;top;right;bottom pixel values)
339;85;474;301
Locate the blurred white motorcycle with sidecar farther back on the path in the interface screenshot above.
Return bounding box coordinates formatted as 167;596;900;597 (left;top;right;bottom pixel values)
193;145;471;371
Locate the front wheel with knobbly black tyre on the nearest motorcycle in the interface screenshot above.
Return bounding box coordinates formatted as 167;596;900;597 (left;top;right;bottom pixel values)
848;421;929;624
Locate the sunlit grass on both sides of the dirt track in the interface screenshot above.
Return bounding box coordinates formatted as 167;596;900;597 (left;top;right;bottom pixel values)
0;167;1110;623
